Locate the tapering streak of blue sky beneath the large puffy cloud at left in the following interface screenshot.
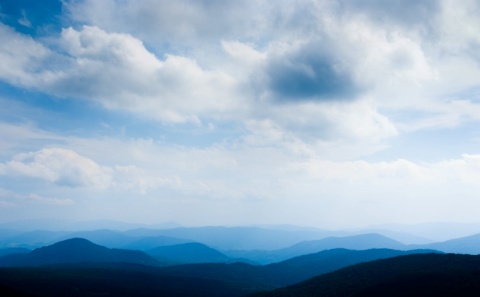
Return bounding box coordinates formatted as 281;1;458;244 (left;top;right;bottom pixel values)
0;82;242;147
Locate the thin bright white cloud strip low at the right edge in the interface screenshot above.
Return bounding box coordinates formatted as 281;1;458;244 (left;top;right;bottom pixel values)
292;154;480;187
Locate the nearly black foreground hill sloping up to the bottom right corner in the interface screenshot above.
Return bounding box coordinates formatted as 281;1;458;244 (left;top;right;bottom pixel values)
252;254;480;297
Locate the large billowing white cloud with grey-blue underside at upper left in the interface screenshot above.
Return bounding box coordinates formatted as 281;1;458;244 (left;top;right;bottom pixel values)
0;25;240;123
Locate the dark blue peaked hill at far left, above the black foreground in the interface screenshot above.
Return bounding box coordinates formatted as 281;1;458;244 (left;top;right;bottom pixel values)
0;238;159;267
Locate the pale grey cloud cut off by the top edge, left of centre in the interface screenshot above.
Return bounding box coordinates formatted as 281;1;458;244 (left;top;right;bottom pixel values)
65;0;271;46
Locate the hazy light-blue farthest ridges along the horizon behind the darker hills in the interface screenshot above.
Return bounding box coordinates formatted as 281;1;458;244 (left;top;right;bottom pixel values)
4;227;480;265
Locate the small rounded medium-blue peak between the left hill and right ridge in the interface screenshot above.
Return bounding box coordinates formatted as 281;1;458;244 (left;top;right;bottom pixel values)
147;242;230;263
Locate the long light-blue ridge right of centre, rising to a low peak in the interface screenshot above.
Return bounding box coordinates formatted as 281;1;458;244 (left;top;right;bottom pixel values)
226;233;406;264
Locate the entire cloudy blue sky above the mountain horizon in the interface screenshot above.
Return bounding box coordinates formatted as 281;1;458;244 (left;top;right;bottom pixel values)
0;0;480;228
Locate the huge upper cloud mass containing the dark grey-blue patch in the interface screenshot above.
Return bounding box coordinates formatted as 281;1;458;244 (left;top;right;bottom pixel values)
0;0;480;160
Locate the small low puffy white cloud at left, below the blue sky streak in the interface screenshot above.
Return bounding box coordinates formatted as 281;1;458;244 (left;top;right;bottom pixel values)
0;143;181;194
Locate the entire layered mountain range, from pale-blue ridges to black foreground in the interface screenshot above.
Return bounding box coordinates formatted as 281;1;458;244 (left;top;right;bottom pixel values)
0;227;480;297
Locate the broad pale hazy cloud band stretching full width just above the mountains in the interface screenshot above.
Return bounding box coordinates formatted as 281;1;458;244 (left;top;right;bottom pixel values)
0;120;480;227
